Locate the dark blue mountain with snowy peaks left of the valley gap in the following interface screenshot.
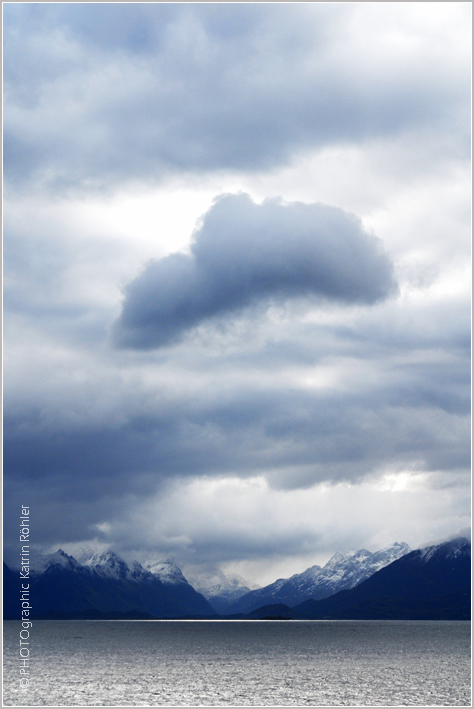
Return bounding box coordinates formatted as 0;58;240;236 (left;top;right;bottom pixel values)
4;549;215;618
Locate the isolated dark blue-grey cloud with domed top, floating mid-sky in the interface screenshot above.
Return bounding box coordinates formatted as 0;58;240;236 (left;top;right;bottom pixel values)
115;194;395;348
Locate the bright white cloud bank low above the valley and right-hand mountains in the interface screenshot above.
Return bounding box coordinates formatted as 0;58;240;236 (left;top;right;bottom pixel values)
114;472;469;582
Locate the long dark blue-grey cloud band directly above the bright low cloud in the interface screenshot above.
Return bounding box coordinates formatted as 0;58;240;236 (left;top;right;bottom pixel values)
4;372;470;556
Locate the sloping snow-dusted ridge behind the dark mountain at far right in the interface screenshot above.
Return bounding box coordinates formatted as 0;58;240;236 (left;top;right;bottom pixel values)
229;542;410;613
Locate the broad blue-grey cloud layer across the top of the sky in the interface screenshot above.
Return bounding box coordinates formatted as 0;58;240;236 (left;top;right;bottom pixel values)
4;3;470;189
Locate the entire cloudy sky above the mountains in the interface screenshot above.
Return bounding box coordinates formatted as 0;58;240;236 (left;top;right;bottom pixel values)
3;2;471;584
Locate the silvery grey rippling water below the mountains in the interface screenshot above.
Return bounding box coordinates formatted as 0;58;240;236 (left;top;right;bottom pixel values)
4;621;470;706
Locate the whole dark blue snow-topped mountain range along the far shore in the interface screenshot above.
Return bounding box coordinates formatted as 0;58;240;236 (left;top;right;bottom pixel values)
4;538;471;619
